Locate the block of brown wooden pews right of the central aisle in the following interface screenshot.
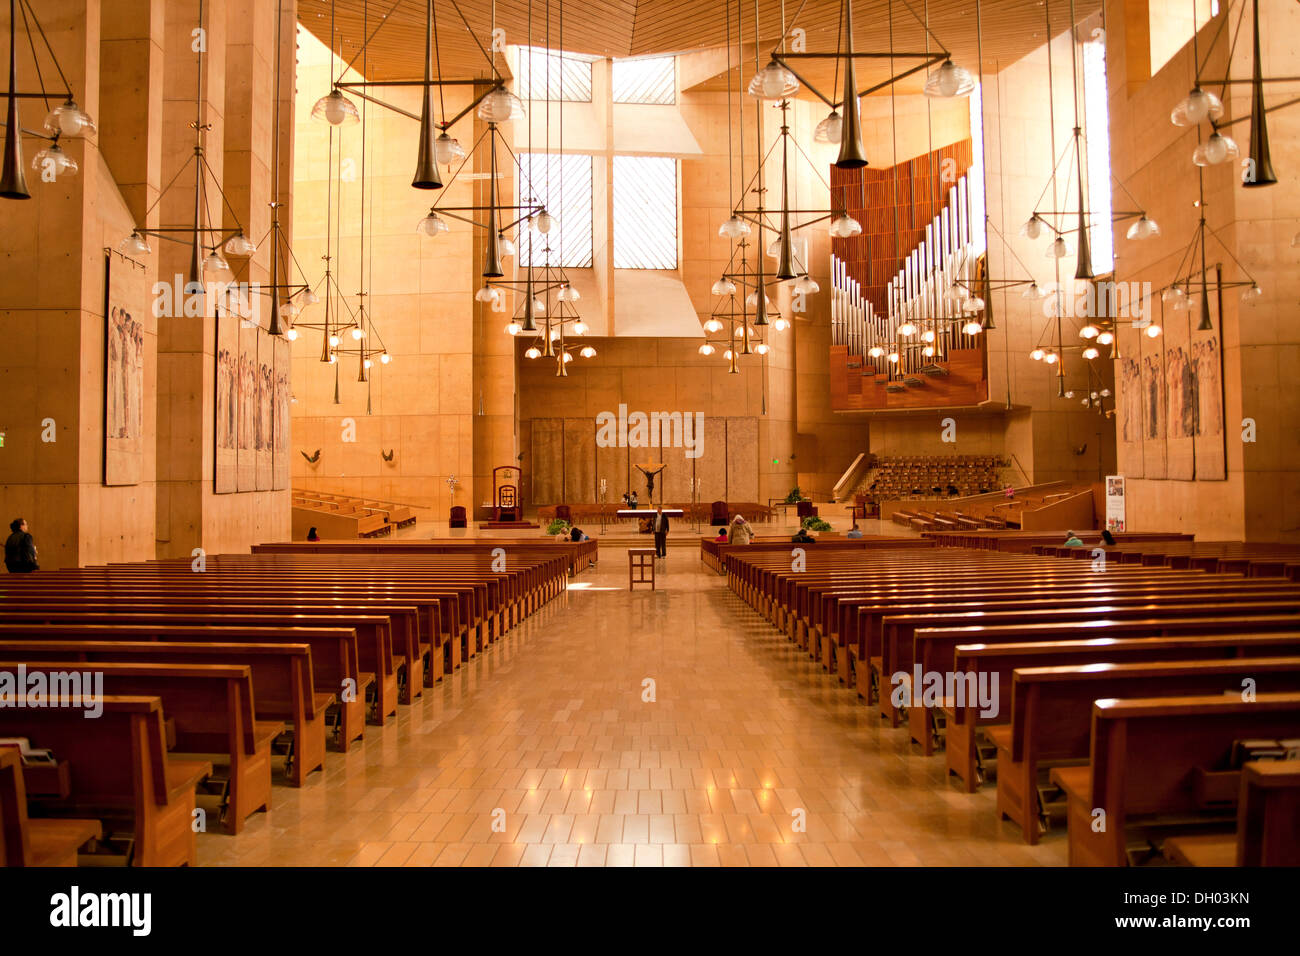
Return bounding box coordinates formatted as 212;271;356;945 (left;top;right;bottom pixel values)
722;538;1300;865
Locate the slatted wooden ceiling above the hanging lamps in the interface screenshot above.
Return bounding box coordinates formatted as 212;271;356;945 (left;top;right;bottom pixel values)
298;0;1101;98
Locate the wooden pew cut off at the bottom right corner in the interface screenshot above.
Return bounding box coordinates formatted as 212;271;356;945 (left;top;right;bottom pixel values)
1164;760;1300;866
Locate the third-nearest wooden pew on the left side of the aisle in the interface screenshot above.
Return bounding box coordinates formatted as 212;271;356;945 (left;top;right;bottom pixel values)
0;656;276;834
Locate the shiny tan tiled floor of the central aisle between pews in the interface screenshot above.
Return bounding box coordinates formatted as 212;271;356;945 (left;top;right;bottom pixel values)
199;548;1066;866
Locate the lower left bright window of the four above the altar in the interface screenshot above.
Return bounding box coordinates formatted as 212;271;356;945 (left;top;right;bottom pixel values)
517;152;592;269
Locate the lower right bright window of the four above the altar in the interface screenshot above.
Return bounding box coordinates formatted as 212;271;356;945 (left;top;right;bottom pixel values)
614;156;677;269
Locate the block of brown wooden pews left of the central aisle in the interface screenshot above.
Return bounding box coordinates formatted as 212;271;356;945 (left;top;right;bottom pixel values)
0;538;594;866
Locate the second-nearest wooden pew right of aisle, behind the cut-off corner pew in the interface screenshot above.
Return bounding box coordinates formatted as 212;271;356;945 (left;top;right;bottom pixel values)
1052;693;1300;866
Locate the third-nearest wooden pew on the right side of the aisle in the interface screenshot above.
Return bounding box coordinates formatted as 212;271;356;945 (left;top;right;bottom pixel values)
977;655;1300;843
